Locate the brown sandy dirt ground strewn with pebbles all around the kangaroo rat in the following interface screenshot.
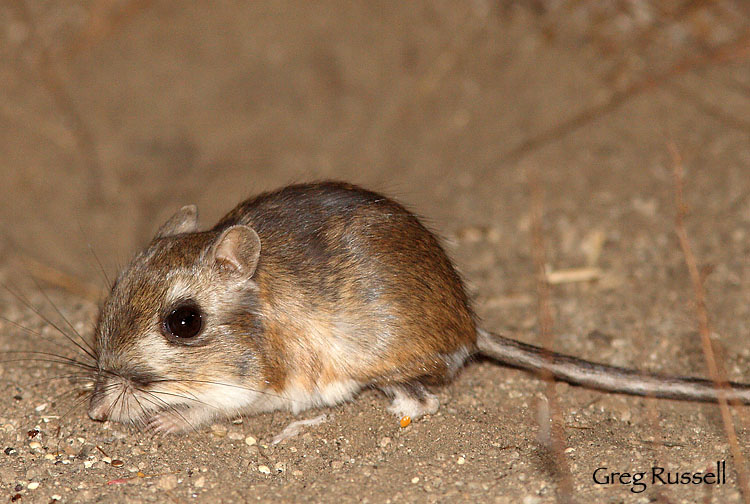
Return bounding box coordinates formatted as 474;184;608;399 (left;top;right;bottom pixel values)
0;0;750;504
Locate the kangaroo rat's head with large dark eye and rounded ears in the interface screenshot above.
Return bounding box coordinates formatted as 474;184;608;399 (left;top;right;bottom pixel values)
89;206;262;430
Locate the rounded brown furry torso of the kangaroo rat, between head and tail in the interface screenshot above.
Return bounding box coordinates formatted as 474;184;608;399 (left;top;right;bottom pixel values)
213;182;476;386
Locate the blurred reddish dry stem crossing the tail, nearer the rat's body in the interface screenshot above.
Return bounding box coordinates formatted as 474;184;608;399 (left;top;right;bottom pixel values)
526;169;575;503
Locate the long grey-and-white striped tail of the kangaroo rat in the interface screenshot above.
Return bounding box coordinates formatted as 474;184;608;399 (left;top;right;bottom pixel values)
477;329;750;404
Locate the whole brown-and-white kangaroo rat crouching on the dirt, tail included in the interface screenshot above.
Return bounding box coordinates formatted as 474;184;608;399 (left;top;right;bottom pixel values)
89;182;750;432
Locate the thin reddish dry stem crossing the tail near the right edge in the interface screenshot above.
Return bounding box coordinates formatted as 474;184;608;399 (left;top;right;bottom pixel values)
667;143;750;504
